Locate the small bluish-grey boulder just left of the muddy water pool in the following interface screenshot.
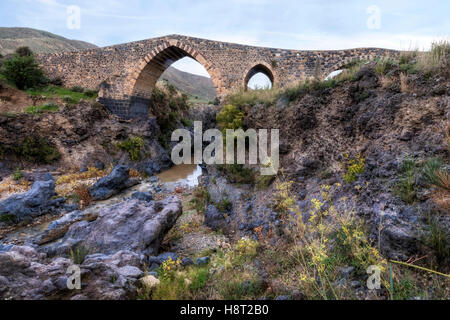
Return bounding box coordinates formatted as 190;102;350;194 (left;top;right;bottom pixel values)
89;165;138;200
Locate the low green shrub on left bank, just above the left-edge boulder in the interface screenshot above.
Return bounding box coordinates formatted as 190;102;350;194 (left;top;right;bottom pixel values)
14;136;61;164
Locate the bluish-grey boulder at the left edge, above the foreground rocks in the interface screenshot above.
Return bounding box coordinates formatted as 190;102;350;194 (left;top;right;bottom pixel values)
0;175;65;222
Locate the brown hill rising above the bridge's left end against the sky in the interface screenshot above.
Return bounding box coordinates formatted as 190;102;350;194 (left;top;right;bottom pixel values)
0;28;97;55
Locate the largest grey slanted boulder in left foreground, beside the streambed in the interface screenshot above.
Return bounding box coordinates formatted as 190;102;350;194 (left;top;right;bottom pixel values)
43;196;182;256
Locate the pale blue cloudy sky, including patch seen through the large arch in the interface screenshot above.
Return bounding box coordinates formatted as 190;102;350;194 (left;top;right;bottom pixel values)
0;0;450;86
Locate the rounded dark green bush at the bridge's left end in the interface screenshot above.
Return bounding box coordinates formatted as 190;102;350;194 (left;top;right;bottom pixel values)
0;54;46;90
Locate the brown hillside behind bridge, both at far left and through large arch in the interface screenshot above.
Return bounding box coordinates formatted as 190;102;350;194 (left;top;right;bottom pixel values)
0;27;216;101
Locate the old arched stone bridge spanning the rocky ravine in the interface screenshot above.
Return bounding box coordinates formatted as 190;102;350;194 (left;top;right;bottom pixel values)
37;35;398;118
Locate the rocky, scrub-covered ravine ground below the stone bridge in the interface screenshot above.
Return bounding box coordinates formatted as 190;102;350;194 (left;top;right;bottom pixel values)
0;58;450;300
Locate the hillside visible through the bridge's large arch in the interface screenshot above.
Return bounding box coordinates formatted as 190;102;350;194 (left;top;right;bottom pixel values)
160;67;216;102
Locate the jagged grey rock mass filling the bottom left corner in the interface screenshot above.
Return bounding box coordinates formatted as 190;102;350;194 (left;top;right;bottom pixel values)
0;246;144;300
